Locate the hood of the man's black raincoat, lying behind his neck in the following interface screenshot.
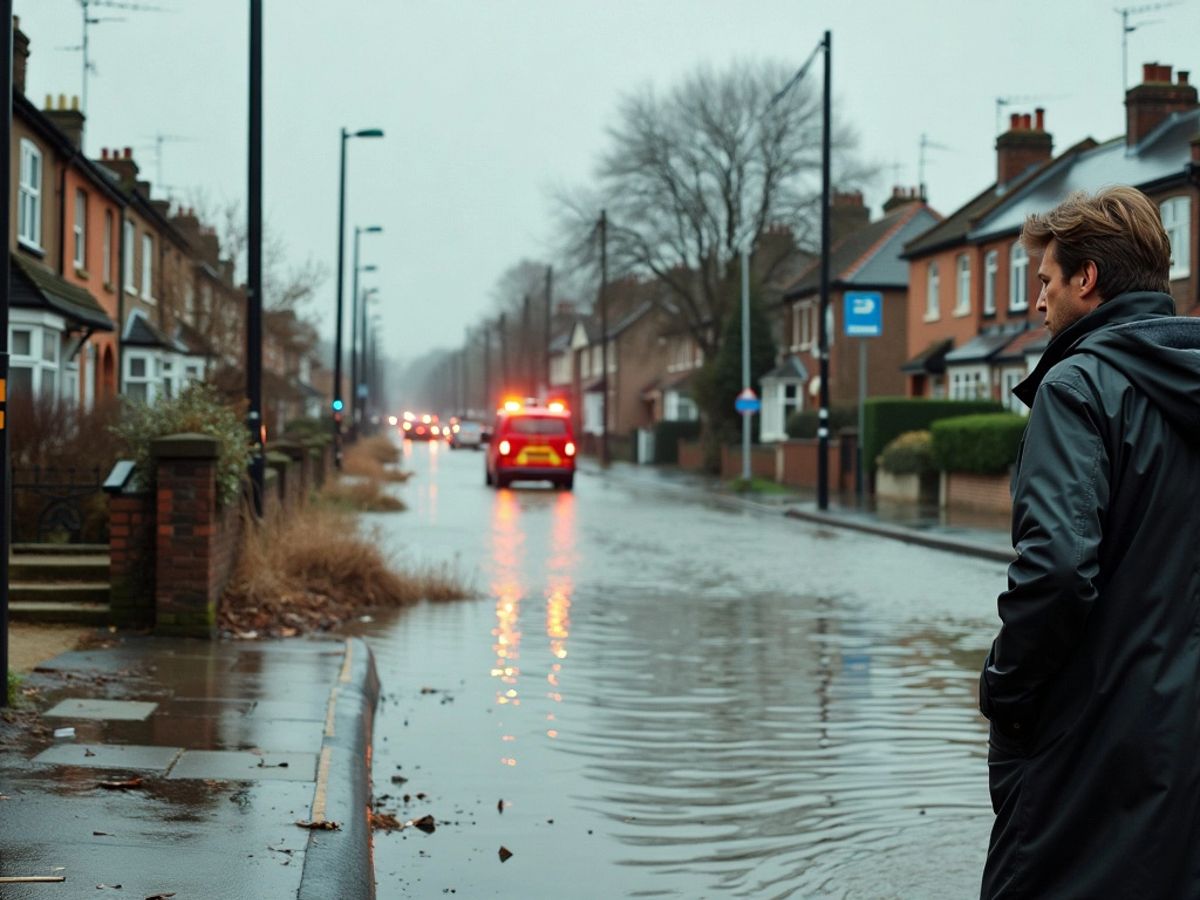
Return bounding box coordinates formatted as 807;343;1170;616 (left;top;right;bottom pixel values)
1014;292;1200;443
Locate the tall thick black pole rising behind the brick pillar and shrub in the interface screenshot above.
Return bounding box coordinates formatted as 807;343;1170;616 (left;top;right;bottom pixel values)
246;0;265;517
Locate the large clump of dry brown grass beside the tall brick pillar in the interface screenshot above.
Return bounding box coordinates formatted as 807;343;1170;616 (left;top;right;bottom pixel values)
221;506;470;637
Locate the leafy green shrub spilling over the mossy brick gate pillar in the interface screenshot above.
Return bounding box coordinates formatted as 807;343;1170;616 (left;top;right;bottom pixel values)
113;382;250;506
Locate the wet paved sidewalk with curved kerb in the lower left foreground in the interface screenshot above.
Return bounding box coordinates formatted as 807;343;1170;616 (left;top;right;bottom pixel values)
0;636;379;900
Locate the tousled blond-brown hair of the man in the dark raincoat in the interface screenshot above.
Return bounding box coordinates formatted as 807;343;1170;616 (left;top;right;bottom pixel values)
1021;186;1171;300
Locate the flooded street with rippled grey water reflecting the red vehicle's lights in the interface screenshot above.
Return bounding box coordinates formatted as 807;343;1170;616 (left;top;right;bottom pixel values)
352;444;1004;899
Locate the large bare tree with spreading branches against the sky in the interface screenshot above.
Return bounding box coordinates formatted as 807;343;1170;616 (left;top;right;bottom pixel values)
560;62;865;358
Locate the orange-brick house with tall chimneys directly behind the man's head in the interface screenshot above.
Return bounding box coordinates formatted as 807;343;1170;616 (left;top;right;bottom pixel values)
904;64;1200;412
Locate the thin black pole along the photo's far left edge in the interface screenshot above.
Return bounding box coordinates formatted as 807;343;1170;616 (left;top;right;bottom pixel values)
0;0;12;707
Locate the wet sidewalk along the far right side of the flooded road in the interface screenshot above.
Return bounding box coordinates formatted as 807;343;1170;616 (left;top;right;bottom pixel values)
581;460;1013;563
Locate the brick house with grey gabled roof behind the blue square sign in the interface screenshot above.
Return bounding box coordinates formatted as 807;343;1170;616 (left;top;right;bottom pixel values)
760;188;941;440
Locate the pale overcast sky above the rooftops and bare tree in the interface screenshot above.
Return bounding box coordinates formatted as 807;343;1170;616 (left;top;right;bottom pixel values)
14;0;1200;372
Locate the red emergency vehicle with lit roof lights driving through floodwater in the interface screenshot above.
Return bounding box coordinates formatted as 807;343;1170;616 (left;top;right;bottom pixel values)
485;401;576;491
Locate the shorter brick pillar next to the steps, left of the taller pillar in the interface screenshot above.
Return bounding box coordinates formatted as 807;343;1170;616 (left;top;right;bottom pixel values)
108;491;155;628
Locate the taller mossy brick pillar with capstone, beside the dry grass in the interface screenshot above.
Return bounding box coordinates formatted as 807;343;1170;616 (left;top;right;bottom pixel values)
150;434;225;638
